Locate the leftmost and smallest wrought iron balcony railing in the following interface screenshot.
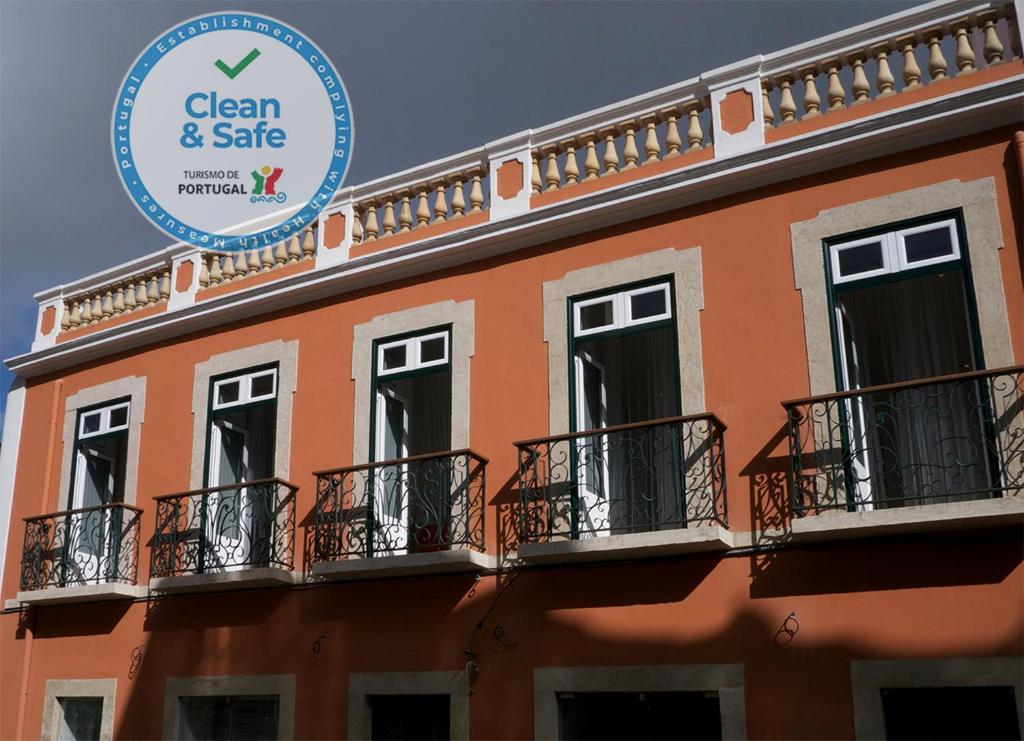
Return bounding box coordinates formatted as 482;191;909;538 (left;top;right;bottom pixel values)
20;505;142;592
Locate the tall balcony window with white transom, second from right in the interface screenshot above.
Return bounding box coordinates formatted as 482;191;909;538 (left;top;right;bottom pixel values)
569;280;685;537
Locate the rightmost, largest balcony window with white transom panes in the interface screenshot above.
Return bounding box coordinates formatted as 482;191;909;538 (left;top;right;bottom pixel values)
826;218;992;510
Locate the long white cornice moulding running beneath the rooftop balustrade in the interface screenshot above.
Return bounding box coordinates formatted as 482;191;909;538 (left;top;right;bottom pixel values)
5;75;1024;378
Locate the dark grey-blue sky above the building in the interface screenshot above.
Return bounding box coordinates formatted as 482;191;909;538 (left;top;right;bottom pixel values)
0;0;919;429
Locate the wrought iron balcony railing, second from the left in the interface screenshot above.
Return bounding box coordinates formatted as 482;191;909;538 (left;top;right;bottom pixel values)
150;478;298;577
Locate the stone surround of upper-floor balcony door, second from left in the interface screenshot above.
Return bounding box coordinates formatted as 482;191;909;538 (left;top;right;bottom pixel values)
188;340;299;489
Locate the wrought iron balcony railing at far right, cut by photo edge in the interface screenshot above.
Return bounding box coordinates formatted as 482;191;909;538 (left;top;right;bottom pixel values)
782;365;1024;516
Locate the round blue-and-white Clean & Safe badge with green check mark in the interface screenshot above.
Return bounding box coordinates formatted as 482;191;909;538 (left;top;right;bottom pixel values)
112;11;352;252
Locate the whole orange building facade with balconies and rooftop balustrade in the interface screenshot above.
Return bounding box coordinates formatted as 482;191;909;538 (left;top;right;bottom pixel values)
0;0;1024;738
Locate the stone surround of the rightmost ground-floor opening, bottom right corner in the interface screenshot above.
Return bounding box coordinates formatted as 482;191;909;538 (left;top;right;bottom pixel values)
850;656;1024;739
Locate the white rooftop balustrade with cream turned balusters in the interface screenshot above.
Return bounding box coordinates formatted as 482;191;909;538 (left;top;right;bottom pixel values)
33;0;1021;348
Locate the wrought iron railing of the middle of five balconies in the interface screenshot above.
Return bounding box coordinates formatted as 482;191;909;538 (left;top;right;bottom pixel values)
313;449;487;562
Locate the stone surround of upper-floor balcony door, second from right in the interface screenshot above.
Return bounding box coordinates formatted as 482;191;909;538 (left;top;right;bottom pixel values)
544;247;705;435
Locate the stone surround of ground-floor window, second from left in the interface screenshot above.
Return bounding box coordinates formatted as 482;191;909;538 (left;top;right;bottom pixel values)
163;674;295;739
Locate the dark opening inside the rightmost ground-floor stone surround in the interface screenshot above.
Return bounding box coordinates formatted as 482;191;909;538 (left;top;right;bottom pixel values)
882;687;1021;740
